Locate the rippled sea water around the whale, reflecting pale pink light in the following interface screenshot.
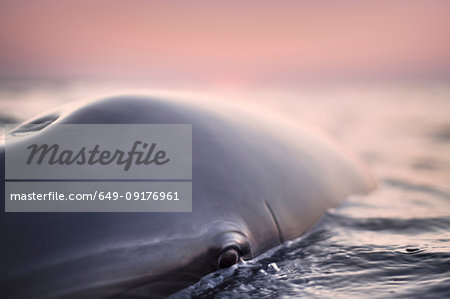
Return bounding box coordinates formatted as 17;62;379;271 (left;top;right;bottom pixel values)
1;85;450;298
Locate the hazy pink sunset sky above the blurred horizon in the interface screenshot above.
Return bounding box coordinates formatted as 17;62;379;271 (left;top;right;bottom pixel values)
0;0;450;83
